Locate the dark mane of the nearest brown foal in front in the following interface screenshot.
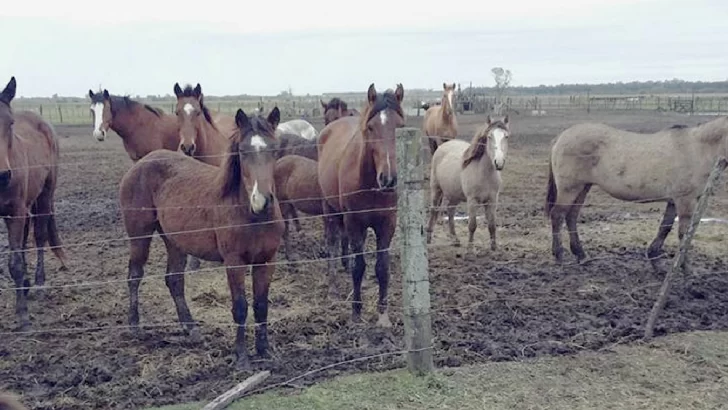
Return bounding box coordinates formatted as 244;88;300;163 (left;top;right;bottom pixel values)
220;115;275;199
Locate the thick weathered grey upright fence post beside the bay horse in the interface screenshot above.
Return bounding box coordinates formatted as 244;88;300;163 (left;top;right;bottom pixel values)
396;128;434;374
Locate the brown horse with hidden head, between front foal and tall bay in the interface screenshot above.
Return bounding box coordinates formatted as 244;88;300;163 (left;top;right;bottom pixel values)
275;155;349;269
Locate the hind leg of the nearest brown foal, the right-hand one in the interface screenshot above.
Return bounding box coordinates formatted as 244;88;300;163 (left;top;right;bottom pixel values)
162;236;202;343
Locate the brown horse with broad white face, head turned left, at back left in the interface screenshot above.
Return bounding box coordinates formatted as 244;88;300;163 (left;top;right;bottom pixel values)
88;90;179;162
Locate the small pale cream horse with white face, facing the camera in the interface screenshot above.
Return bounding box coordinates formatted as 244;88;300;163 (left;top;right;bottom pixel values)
427;116;511;252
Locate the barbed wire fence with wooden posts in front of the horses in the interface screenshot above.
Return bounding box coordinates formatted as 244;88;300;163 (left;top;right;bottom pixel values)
0;128;728;406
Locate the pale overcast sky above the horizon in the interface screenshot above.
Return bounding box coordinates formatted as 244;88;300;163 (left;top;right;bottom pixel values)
0;0;728;96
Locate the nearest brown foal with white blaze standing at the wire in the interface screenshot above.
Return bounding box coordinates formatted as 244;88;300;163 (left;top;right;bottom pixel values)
119;108;284;369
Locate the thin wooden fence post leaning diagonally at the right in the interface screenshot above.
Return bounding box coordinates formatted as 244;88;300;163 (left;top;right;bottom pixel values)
645;157;728;340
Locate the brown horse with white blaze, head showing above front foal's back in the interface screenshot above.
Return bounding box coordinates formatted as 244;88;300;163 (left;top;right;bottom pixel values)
174;83;232;166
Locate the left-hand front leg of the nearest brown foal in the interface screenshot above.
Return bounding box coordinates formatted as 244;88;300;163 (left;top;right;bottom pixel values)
225;258;250;370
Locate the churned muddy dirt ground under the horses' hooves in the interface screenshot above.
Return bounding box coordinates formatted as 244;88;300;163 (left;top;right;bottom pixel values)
0;108;728;409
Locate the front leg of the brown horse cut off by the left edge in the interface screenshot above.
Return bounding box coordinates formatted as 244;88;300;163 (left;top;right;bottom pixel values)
5;215;30;331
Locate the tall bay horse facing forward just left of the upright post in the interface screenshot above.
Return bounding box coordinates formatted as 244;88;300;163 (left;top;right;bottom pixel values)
318;83;405;327
